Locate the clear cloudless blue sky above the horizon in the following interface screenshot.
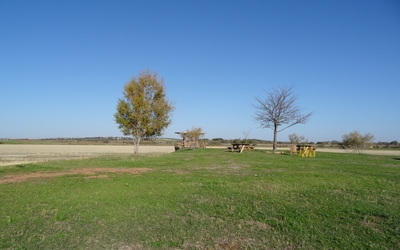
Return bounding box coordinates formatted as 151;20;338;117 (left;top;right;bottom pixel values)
0;0;400;142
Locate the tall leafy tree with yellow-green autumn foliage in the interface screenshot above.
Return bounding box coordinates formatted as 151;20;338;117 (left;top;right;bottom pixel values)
114;70;174;156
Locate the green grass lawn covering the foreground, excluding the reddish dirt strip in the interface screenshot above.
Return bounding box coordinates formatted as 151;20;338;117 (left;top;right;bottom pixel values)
0;149;400;249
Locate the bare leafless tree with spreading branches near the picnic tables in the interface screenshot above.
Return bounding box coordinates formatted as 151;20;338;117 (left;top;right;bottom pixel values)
253;85;313;153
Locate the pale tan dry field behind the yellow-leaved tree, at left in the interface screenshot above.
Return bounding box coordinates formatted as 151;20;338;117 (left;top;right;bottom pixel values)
0;144;175;166
